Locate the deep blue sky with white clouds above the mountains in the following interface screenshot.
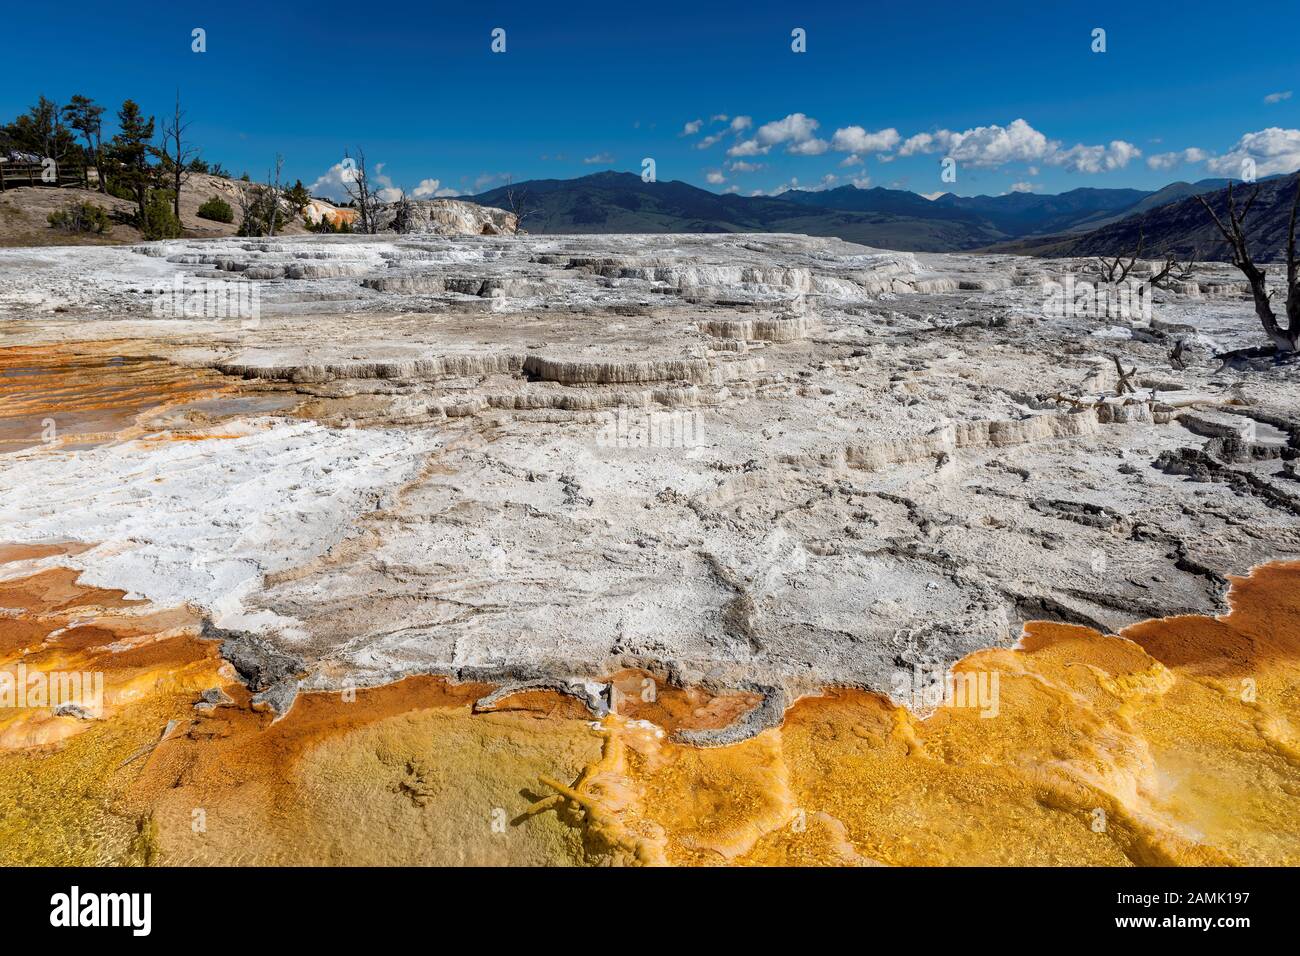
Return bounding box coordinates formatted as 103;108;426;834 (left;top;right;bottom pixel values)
0;0;1300;195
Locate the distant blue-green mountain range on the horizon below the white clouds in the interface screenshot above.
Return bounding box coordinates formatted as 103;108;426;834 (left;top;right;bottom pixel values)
467;172;1248;252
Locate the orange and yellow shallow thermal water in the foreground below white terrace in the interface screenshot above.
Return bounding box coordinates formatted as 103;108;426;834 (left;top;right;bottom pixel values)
0;555;1300;865
